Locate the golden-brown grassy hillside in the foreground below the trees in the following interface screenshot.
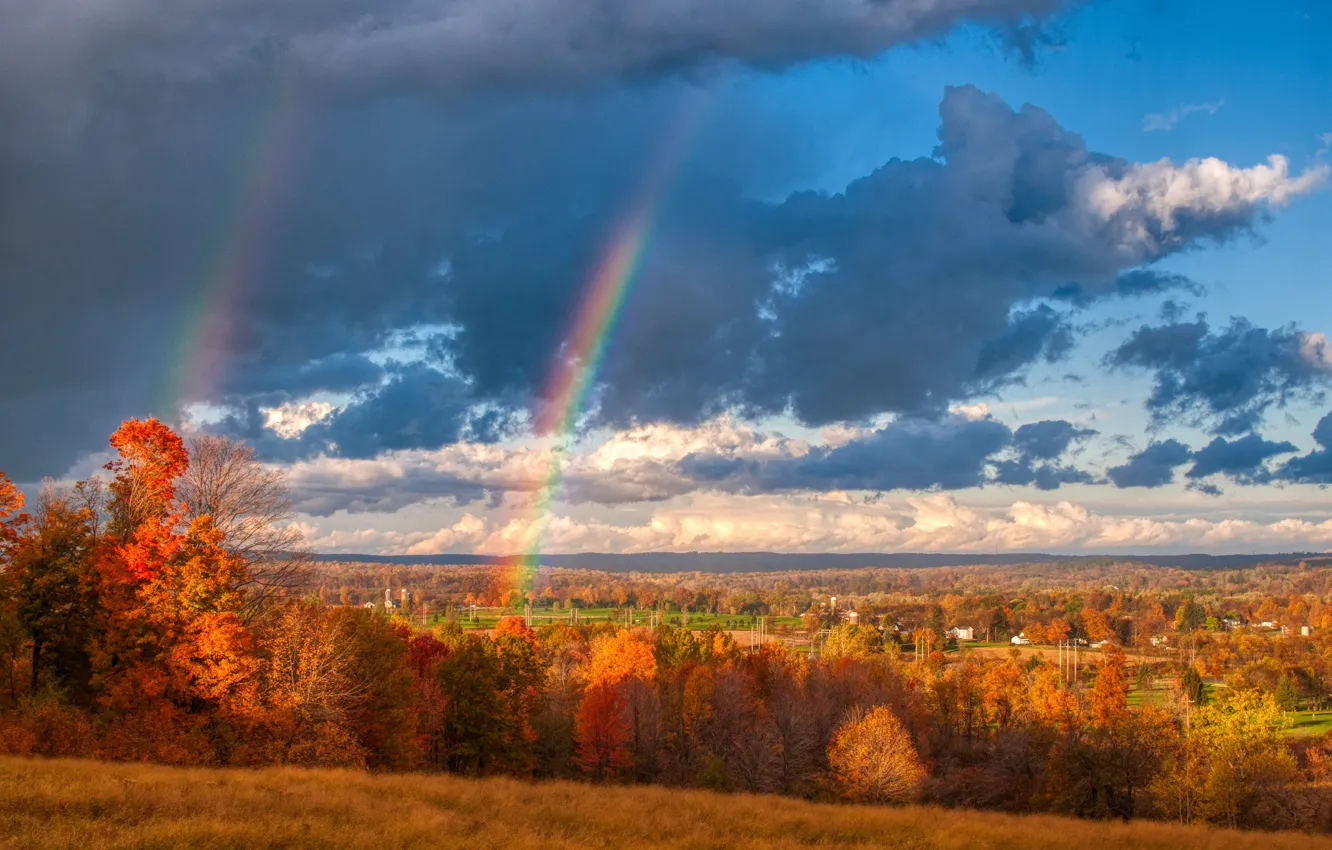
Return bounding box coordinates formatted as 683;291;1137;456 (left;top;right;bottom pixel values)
0;758;1332;850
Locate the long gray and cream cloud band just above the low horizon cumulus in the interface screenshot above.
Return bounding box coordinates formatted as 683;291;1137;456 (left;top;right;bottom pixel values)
281;414;1095;516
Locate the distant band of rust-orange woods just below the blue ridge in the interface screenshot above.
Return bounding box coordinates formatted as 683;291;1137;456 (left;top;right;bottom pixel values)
312;562;1332;647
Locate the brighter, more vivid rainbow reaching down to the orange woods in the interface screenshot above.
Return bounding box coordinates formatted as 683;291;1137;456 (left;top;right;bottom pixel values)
505;99;705;607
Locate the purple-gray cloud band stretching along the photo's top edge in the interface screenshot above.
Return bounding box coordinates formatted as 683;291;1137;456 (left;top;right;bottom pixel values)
0;0;1075;107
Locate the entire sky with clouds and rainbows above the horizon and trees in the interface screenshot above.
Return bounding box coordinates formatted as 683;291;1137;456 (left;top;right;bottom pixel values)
0;0;1332;554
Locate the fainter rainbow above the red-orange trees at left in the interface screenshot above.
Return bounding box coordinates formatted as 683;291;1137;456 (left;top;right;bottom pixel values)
159;72;304;417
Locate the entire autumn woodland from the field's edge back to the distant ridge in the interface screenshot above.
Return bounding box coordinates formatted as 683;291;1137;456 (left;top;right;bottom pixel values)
0;420;1332;830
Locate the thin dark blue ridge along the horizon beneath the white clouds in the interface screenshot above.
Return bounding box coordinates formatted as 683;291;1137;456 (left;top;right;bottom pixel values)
306;552;1332;573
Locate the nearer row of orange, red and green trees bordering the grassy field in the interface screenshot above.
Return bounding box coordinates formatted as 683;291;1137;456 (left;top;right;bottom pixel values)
0;420;1332;830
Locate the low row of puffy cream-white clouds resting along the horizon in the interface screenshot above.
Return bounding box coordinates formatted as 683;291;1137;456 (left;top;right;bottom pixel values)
297;494;1332;554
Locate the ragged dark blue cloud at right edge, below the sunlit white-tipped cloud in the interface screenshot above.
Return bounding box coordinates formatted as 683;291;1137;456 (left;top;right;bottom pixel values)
1106;318;1332;436
